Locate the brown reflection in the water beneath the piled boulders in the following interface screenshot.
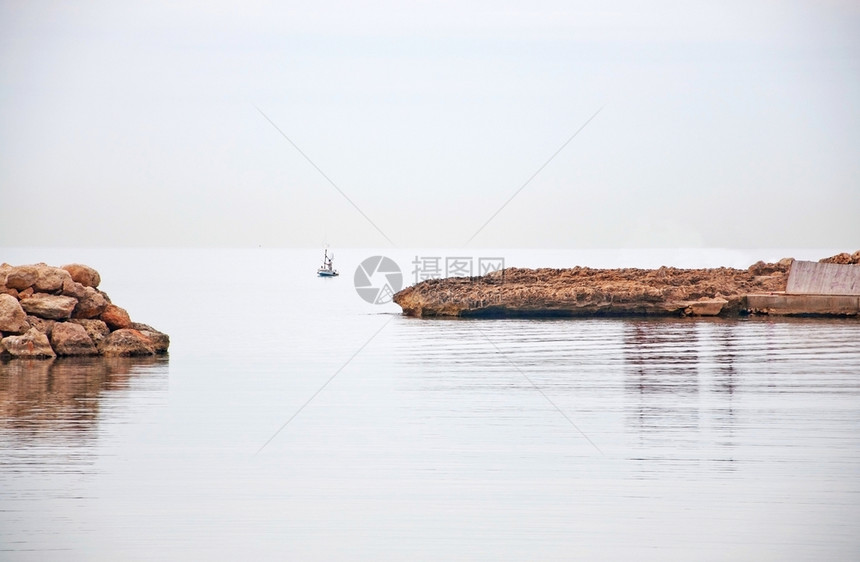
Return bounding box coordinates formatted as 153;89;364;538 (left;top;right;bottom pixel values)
0;356;168;440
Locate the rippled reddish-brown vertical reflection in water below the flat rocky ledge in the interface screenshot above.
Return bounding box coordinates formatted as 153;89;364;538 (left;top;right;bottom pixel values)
623;320;737;475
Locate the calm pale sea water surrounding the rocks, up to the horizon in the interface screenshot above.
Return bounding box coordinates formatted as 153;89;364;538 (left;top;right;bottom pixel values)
0;249;860;560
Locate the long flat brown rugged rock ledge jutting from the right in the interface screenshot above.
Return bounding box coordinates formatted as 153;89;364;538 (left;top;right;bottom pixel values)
393;251;860;317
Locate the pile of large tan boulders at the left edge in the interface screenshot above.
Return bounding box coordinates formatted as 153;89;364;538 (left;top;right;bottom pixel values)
0;263;170;359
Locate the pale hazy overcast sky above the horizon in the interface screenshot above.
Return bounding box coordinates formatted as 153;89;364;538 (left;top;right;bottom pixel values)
0;0;860;250
